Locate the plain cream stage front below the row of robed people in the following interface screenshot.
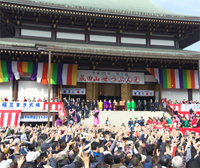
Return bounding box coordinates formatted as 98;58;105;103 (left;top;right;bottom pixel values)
80;111;170;126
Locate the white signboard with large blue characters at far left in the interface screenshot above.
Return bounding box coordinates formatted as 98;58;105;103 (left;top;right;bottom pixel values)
0;102;44;110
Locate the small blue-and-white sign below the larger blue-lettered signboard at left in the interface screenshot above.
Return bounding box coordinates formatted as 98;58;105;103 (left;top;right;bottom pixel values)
20;115;52;122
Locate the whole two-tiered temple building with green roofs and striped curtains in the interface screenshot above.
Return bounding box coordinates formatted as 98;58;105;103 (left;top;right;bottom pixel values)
0;0;200;101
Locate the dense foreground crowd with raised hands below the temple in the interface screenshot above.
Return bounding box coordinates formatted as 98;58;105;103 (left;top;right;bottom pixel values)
0;120;200;168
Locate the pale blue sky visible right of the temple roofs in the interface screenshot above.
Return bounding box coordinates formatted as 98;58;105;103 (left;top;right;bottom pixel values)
153;0;200;52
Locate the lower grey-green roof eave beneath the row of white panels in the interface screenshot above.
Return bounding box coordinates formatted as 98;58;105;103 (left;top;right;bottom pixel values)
0;38;200;60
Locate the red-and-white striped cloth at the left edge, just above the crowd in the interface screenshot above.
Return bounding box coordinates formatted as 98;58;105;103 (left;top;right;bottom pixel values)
0;110;22;127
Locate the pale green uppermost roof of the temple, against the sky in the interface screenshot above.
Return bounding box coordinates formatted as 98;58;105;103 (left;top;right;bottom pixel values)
1;0;200;21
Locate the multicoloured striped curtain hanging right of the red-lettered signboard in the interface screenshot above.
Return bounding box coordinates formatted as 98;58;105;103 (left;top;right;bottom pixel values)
146;68;199;89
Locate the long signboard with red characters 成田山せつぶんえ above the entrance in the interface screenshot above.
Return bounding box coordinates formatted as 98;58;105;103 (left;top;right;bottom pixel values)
77;70;144;84
